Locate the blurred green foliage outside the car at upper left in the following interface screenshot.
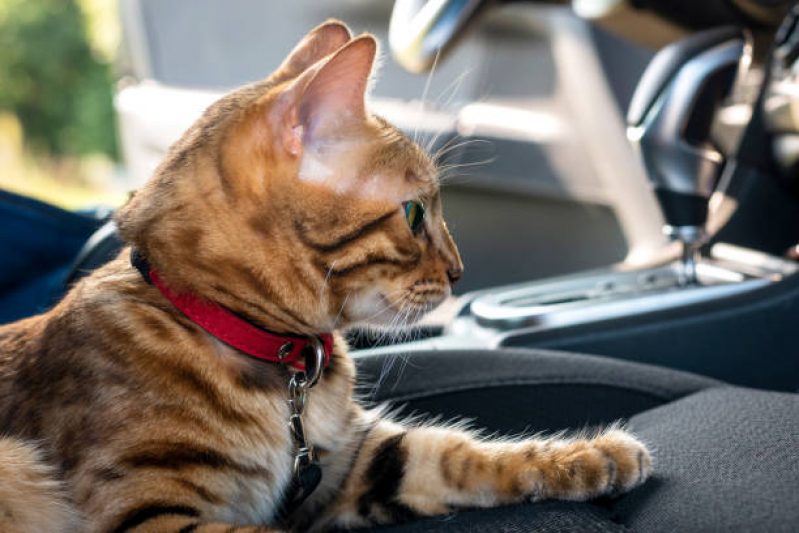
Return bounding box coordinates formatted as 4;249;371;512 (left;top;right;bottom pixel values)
0;0;117;158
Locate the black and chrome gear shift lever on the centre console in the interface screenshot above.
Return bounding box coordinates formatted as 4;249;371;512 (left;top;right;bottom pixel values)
627;28;743;284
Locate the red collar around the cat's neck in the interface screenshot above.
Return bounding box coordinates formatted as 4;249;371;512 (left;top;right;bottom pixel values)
131;250;333;370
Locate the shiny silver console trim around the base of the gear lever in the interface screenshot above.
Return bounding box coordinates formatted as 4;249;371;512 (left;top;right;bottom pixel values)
360;244;799;353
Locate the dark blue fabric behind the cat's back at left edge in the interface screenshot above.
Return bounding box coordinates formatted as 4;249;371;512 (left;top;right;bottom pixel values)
0;190;102;324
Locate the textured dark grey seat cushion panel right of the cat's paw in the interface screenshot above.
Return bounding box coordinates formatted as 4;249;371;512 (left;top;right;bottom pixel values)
612;387;799;532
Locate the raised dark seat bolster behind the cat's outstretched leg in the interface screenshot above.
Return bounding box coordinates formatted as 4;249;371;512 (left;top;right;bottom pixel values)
356;349;722;434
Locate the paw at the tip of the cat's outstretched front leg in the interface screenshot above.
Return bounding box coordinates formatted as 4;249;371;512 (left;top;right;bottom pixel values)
540;429;652;500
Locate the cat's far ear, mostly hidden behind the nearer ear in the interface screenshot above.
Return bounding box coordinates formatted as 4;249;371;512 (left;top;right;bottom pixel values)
270;20;352;81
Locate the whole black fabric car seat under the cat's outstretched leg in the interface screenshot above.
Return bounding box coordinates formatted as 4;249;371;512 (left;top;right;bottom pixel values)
358;350;799;533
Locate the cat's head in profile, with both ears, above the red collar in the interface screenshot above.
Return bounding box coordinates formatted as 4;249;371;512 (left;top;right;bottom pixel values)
117;21;462;333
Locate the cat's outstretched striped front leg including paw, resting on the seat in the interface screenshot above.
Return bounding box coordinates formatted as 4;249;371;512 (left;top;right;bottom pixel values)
322;420;651;527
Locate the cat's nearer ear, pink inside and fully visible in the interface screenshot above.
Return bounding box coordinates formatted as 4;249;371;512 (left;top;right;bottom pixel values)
276;34;377;155
